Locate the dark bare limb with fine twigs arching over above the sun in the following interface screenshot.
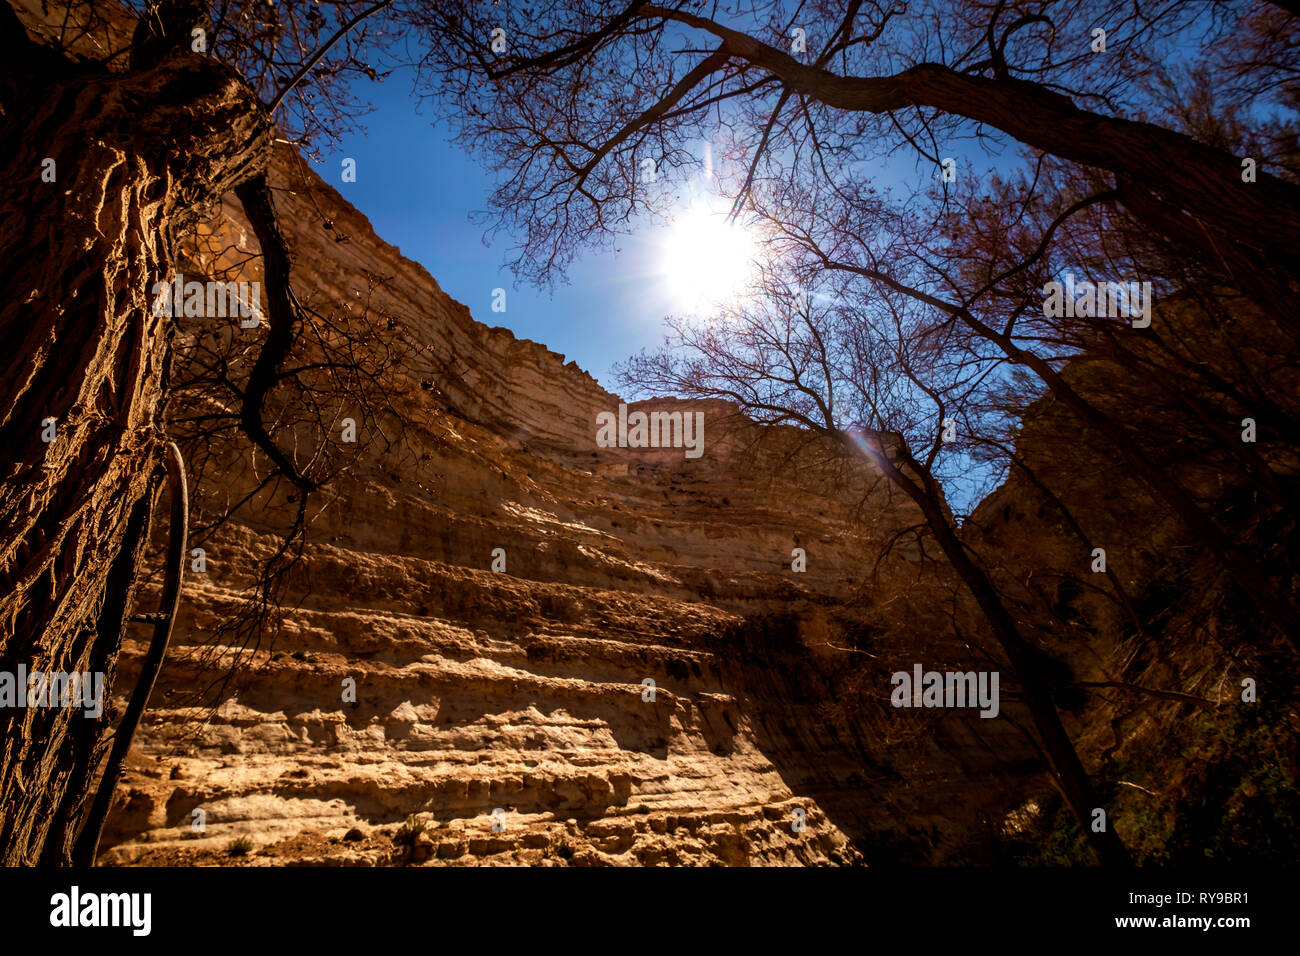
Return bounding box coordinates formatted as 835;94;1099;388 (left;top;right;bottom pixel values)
413;0;1300;285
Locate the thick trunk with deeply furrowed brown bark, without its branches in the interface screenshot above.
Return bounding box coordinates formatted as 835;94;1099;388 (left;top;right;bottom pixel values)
0;17;270;864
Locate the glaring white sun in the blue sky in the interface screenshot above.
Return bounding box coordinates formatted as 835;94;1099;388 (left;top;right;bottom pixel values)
664;208;758;312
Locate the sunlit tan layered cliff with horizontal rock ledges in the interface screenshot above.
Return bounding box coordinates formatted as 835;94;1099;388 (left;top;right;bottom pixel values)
94;147;1026;865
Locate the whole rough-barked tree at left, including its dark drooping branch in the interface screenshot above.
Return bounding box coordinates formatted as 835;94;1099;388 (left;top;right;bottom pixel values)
0;0;386;864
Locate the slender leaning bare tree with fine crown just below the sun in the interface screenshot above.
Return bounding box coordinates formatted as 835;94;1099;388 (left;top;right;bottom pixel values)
621;260;1128;865
